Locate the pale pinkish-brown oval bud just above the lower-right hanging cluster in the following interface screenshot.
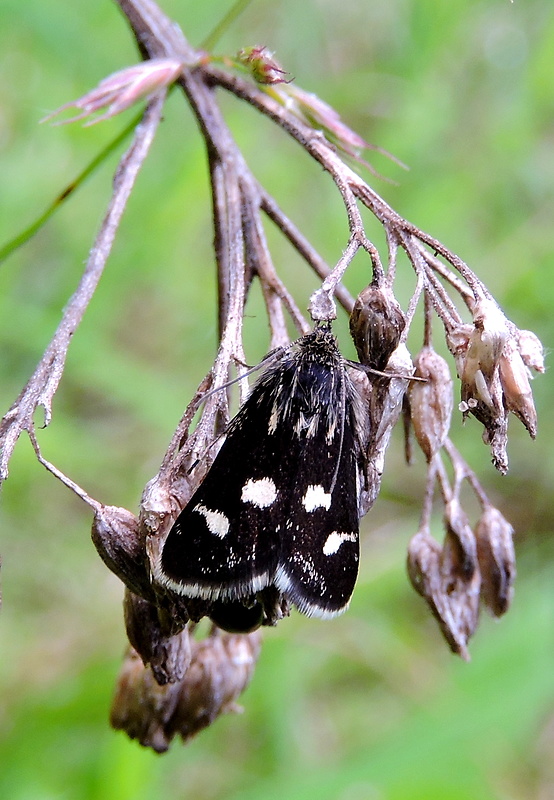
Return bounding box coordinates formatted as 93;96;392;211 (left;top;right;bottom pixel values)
409;346;453;461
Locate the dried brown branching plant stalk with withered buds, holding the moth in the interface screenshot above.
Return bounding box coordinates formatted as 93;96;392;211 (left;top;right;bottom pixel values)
0;0;544;751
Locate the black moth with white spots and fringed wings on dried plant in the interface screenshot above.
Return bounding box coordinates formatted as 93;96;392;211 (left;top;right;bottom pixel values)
153;325;362;630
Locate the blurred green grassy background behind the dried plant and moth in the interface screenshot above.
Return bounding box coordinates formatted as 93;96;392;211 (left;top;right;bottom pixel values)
0;0;554;800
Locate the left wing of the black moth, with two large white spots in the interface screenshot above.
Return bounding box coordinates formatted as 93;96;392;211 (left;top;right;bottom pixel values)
154;390;282;600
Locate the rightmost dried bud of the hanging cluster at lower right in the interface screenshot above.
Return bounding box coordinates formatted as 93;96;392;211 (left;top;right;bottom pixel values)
475;506;516;617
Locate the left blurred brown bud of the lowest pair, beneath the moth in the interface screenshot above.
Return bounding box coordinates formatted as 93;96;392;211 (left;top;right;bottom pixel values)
110;648;181;753
